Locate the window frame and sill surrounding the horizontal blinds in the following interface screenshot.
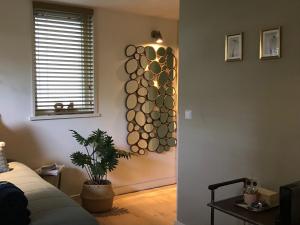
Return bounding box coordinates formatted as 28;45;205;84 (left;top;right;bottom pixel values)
29;1;101;121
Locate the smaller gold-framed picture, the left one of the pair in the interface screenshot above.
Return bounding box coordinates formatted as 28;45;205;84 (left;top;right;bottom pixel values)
225;33;243;62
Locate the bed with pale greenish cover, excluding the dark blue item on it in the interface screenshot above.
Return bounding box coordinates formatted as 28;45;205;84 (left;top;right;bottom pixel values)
0;162;98;225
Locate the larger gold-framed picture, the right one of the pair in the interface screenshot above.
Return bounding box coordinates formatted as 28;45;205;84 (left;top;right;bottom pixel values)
259;27;281;59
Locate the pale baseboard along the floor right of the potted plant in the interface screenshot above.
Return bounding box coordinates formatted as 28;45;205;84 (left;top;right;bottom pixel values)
114;177;176;195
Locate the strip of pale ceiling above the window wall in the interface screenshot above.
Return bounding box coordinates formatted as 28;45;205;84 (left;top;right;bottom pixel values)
39;0;179;20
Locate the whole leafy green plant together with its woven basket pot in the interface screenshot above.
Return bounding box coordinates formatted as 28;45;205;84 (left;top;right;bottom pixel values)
70;129;131;212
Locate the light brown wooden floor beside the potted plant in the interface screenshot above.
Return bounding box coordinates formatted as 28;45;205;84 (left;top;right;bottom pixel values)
95;185;176;225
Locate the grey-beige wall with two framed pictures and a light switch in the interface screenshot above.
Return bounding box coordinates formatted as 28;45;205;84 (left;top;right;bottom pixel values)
178;0;300;225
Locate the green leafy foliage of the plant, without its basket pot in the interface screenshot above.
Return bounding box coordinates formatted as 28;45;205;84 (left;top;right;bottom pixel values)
70;129;131;184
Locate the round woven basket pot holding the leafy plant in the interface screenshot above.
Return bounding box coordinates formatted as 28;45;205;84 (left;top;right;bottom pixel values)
80;182;115;213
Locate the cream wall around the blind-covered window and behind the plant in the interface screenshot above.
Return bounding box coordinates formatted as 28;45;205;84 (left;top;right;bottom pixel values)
0;0;177;194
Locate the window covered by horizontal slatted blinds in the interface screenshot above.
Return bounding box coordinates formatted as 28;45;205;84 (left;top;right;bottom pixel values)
33;2;95;117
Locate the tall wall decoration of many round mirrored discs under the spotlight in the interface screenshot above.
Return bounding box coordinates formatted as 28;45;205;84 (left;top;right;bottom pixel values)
125;45;177;155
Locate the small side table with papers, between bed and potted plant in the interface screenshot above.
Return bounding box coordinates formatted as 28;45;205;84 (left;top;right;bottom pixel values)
35;163;65;189
